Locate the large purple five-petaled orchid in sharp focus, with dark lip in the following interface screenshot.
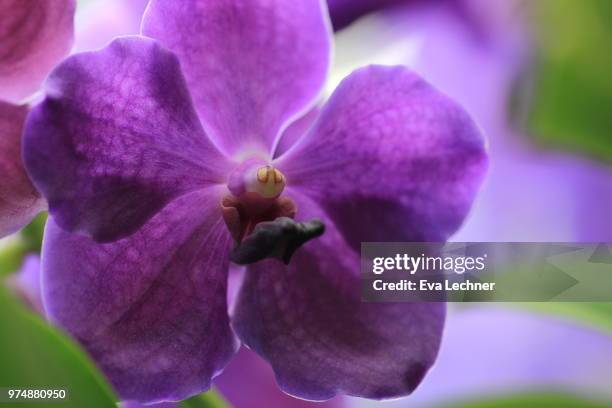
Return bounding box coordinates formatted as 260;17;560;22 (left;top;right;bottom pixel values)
24;0;486;402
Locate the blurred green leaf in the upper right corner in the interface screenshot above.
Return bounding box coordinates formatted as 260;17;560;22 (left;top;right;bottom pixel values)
517;0;612;162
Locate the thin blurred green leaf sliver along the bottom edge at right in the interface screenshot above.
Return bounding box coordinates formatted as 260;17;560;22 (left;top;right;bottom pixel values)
439;392;611;408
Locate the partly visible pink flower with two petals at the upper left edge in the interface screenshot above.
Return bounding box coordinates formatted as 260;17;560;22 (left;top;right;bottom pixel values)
0;0;75;238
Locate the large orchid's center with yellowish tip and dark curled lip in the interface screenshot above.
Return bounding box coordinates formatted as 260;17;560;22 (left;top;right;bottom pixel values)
221;160;324;264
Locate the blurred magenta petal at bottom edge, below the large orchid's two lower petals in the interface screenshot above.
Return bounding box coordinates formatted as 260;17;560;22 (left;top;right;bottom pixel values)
214;347;346;408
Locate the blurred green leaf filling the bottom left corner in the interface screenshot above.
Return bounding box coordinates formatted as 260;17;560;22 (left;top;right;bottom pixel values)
0;286;117;408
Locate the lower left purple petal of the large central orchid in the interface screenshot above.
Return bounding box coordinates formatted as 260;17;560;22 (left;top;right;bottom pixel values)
43;187;237;402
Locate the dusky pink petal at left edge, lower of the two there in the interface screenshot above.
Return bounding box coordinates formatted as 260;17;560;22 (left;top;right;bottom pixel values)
0;101;45;238
